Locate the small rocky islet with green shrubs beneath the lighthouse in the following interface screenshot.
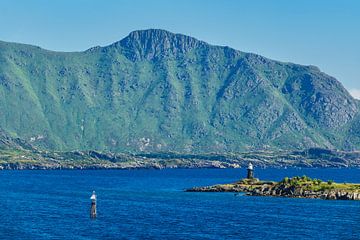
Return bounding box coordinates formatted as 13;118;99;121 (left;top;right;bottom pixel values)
185;176;360;200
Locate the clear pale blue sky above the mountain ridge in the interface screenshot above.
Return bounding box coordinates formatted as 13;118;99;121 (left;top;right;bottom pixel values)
0;0;360;97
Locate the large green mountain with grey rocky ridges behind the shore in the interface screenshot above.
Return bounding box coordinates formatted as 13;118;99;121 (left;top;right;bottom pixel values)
0;29;360;153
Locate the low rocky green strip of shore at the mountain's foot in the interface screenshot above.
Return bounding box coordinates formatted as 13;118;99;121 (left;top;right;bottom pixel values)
0;148;360;170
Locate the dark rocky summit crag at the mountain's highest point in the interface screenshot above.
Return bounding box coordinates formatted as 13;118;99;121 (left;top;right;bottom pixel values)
115;29;206;61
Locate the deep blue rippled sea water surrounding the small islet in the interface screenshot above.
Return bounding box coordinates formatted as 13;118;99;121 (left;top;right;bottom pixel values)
0;169;360;239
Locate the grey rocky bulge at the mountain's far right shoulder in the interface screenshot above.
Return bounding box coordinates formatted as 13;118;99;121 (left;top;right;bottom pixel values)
283;69;359;128
